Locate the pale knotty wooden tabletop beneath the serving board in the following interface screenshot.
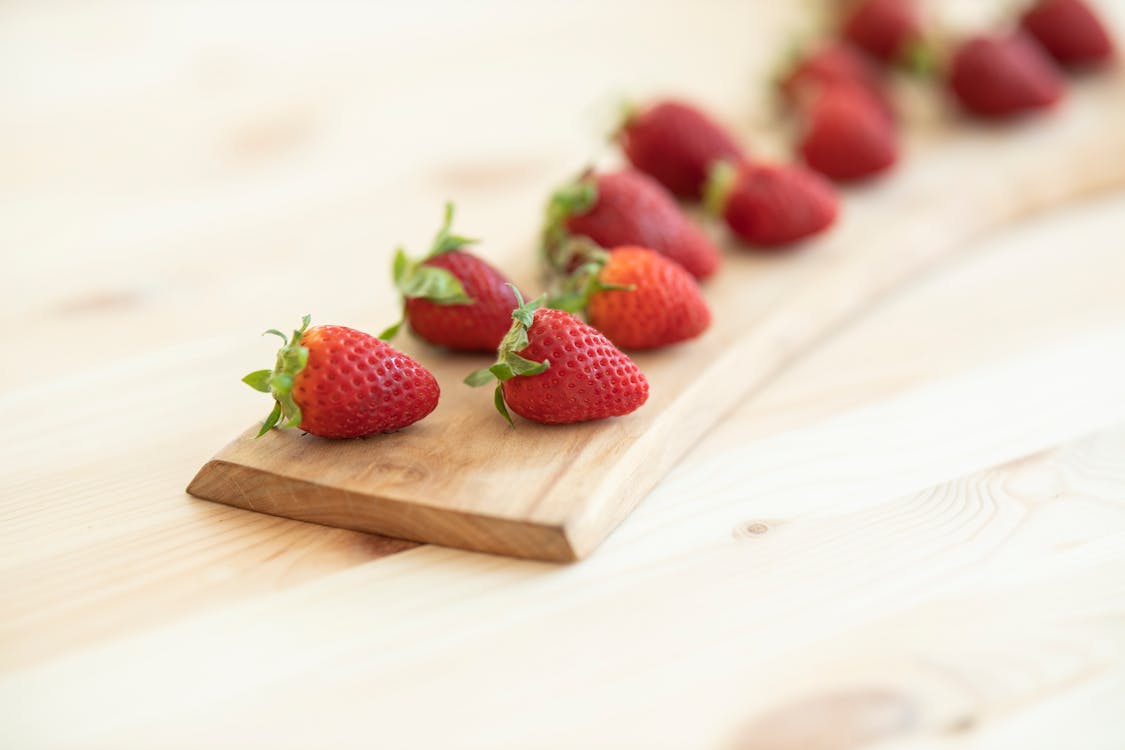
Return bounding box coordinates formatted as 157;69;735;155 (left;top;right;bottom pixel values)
0;3;1125;750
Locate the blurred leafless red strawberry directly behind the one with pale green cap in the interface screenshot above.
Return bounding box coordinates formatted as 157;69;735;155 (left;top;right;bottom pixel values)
801;84;898;181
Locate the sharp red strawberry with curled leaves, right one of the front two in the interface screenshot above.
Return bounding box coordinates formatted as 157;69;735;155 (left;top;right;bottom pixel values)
465;295;648;424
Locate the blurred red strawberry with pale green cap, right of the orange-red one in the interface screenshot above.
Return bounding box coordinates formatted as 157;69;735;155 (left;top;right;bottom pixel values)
707;164;839;247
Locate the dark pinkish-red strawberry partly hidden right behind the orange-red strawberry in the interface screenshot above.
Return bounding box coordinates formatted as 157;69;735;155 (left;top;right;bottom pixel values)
543;170;719;279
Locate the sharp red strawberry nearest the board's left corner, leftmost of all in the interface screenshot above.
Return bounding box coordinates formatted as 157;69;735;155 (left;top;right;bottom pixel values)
242;315;439;437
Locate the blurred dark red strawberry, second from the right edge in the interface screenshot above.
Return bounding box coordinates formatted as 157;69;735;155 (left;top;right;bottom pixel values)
950;33;1063;118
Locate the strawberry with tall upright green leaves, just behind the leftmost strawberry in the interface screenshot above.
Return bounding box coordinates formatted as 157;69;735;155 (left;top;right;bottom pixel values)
379;204;515;352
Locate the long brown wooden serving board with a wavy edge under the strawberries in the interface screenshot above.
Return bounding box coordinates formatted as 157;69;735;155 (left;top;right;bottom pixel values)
188;74;1125;561
